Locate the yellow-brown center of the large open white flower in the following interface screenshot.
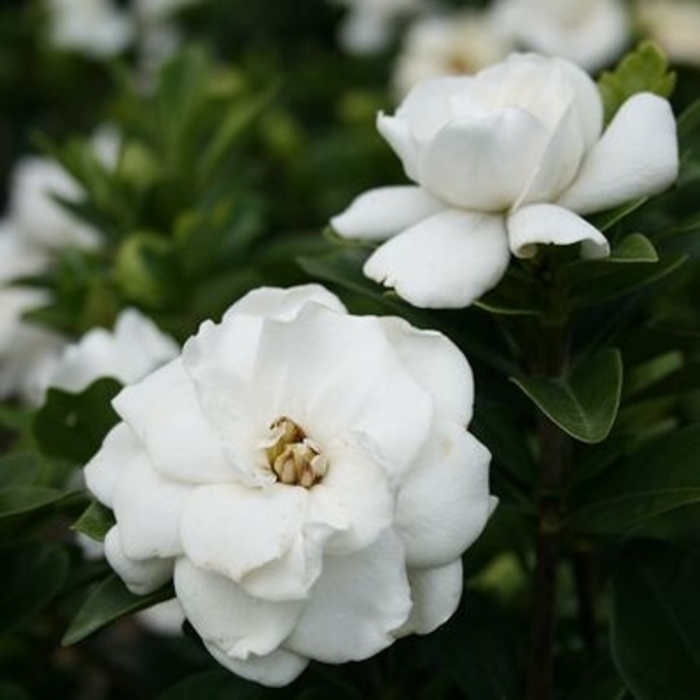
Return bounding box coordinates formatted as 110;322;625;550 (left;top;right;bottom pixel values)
265;416;328;489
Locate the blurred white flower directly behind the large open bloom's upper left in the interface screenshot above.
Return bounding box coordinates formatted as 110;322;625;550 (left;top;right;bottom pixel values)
39;309;180;400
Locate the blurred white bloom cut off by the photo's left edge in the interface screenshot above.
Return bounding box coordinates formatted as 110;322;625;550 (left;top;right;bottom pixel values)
0;221;65;403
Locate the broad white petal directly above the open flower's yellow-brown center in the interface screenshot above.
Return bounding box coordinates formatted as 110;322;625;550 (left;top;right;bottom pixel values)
252;306;433;482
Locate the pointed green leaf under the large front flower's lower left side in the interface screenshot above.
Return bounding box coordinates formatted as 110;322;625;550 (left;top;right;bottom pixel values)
61;574;175;646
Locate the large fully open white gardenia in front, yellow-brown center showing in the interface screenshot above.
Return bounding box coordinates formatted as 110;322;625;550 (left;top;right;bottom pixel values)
85;285;495;685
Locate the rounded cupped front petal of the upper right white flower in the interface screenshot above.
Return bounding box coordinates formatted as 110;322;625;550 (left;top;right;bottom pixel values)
419;108;549;212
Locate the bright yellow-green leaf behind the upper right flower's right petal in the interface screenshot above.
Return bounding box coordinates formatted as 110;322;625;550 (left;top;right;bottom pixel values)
598;41;676;123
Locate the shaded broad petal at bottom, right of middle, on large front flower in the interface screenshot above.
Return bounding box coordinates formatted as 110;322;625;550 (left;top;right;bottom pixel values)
284;531;411;663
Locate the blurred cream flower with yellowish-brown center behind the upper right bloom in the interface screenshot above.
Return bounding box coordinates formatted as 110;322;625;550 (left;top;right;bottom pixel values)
393;10;515;97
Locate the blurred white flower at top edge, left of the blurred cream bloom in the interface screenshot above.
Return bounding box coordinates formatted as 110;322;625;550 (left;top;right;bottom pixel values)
333;0;424;55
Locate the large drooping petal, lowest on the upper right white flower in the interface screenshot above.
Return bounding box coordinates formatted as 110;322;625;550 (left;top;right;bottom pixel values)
364;209;510;308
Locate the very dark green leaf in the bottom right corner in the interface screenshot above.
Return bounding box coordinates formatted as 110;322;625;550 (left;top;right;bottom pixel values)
611;541;700;700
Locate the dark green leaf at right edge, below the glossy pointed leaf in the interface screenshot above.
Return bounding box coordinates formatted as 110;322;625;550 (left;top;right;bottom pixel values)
570;425;700;534
